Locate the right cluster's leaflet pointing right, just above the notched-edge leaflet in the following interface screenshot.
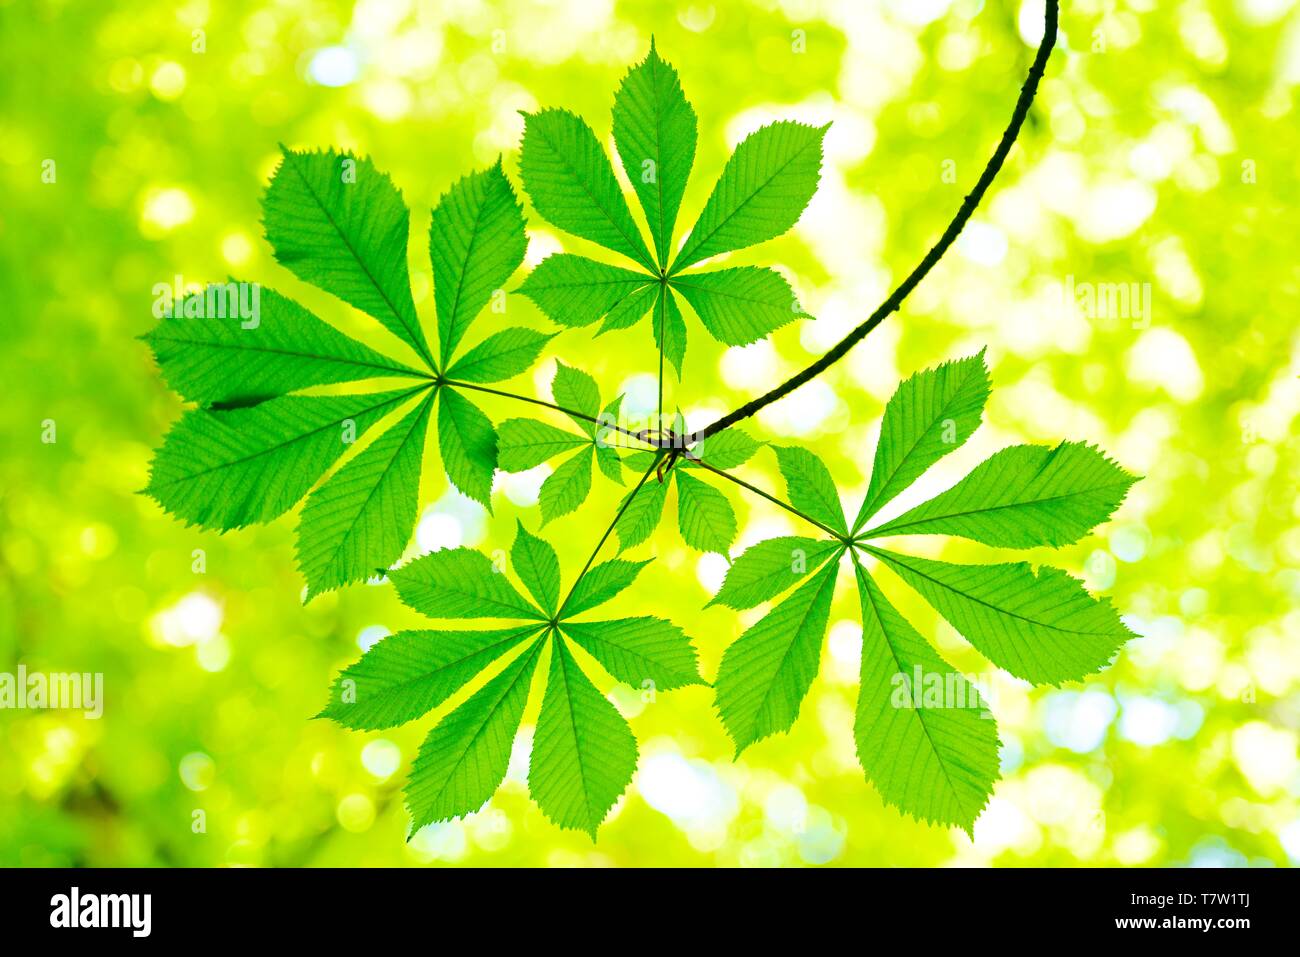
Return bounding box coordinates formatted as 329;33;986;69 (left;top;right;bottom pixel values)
867;442;1136;549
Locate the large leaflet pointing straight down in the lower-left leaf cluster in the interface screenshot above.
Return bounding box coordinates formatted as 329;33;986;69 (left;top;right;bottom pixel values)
528;635;637;840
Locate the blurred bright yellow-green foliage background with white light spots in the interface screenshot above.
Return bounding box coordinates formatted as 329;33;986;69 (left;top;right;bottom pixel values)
0;0;1300;866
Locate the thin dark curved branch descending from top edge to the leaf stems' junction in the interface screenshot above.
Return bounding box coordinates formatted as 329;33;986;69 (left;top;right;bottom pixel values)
688;0;1060;445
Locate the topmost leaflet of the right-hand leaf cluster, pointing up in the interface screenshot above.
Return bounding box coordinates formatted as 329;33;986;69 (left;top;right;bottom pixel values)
853;350;988;532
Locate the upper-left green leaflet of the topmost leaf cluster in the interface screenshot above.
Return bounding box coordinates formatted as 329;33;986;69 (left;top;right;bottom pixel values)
519;109;655;272
